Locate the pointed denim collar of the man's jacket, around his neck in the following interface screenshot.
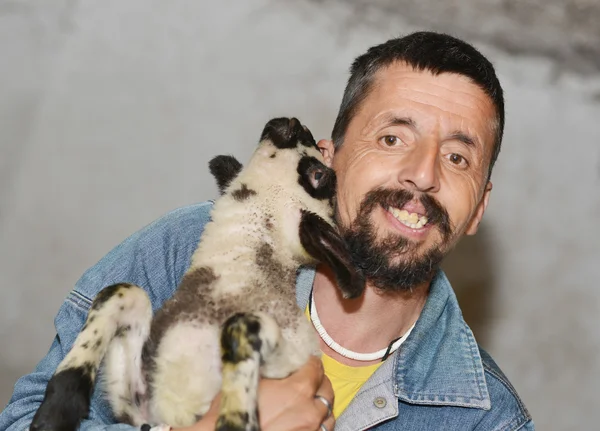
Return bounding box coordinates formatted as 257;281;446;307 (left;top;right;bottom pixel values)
296;267;491;410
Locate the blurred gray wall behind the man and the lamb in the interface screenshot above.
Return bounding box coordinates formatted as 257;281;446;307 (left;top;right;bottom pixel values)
0;0;600;430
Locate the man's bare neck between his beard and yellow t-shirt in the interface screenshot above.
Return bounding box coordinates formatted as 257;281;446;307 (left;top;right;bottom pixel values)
313;265;430;366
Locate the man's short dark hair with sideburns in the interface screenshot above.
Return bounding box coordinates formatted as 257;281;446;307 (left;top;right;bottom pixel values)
331;31;504;179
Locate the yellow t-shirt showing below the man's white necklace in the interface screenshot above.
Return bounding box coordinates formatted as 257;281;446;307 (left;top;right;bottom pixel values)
305;306;383;419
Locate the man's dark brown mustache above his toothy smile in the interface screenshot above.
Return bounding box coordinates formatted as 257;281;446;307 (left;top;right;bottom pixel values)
360;188;453;241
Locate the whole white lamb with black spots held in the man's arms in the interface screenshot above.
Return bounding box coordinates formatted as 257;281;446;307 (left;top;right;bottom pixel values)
30;118;364;431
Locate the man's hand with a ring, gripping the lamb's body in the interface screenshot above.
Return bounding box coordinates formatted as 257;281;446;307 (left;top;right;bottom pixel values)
178;356;335;431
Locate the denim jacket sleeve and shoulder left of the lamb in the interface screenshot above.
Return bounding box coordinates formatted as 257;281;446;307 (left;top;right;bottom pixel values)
0;201;211;431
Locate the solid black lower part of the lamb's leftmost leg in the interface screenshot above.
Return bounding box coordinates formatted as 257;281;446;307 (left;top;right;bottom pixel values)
30;366;93;431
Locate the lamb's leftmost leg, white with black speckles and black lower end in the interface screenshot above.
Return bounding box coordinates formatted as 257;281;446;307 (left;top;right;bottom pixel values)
30;284;151;431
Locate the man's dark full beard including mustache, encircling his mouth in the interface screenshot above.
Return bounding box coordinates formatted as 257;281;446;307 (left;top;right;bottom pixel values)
336;189;453;292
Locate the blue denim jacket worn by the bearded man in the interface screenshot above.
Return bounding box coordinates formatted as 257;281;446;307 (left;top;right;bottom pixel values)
0;201;534;431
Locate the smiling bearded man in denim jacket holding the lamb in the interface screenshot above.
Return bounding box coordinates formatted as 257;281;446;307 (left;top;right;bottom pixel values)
0;32;533;431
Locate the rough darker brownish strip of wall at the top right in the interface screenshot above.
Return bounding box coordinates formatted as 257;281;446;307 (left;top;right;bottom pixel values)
307;0;600;74
